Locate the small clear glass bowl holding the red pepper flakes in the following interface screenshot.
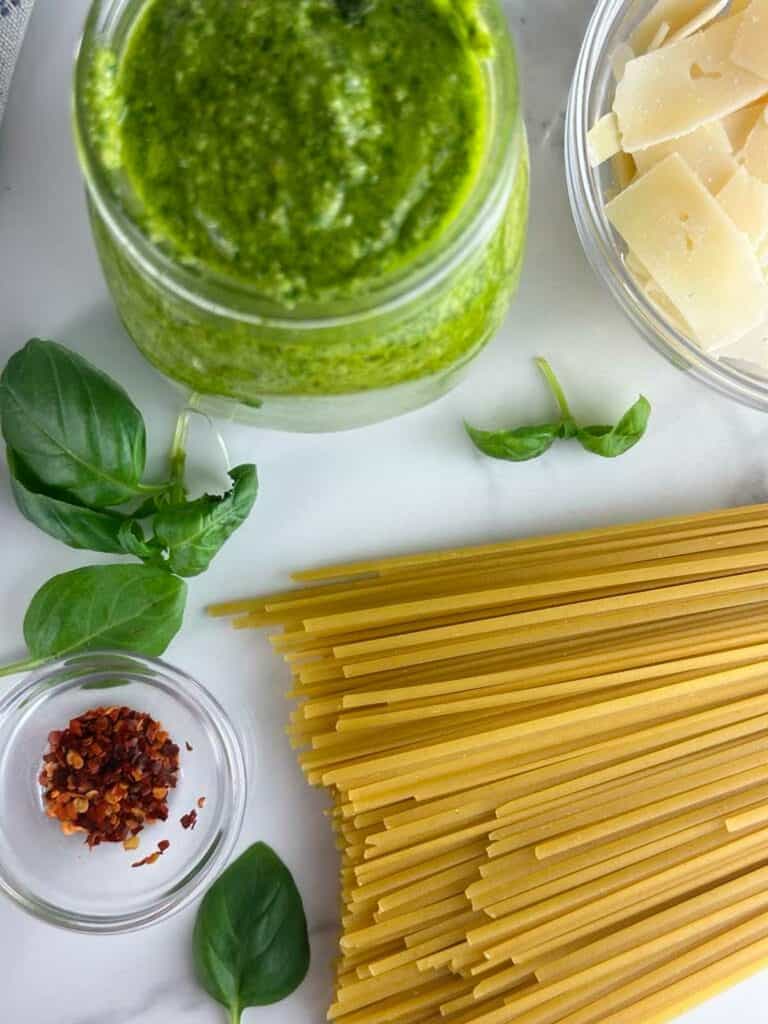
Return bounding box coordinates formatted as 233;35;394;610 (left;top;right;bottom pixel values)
0;651;246;933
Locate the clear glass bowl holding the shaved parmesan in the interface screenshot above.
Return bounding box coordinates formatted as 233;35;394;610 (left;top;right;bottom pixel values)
565;0;768;410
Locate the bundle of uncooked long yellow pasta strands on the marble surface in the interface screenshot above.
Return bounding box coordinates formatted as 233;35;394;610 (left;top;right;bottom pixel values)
211;506;768;1024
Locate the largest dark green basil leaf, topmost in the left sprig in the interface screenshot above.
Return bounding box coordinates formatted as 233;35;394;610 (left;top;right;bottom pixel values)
0;338;146;508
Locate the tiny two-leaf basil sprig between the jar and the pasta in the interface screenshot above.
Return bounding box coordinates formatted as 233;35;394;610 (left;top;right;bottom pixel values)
465;358;650;462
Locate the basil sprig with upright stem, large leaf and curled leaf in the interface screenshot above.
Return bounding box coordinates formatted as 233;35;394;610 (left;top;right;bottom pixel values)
0;338;258;575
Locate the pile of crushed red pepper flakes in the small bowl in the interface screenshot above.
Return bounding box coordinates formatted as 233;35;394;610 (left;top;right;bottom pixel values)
40;708;179;847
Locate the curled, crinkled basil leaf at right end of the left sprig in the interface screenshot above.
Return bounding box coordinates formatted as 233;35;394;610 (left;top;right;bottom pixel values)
155;465;258;577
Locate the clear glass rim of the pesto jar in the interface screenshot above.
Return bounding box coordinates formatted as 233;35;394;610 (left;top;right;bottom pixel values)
73;0;523;330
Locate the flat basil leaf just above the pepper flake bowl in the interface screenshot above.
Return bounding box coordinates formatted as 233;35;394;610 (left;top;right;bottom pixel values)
24;565;186;658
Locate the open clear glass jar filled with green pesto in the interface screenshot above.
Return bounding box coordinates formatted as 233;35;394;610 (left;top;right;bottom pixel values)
75;0;528;431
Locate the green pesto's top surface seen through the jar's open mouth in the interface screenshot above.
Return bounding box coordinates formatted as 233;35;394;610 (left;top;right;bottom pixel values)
90;0;487;307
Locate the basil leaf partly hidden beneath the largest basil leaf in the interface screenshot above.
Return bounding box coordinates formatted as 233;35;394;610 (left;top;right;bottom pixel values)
6;449;130;555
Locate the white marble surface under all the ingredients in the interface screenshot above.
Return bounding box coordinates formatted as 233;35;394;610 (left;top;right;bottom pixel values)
0;0;768;1024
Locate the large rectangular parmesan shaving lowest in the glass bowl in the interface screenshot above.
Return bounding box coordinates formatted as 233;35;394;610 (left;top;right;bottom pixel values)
605;154;768;348
